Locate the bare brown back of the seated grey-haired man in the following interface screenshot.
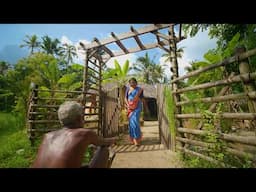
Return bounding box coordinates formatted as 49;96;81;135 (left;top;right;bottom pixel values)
32;128;92;168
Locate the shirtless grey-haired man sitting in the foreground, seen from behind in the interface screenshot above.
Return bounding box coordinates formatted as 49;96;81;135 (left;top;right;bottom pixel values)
31;101;115;168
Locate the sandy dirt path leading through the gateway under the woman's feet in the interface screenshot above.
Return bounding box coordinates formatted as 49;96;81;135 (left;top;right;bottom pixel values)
112;121;182;168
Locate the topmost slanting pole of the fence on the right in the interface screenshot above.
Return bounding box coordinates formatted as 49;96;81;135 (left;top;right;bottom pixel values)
171;49;256;83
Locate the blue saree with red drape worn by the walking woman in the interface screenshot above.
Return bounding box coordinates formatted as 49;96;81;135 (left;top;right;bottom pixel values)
126;87;143;140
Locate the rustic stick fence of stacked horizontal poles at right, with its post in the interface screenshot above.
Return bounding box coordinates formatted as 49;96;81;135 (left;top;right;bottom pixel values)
167;45;256;166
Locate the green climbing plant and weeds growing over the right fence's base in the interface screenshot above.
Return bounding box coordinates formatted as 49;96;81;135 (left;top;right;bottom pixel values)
184;105;252;168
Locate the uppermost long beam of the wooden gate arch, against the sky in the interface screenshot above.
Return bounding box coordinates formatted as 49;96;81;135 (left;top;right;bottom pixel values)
80;24;174;49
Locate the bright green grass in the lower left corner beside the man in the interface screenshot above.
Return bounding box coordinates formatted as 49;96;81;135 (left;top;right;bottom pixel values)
0;113;38;168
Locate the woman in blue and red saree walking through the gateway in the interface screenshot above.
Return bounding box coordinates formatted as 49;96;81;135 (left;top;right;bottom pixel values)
125;78;143;146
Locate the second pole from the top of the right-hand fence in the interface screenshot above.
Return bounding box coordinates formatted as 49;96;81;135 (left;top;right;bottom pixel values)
174;72;256;94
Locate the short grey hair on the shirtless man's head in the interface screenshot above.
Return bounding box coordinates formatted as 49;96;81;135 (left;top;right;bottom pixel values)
58;101;83;125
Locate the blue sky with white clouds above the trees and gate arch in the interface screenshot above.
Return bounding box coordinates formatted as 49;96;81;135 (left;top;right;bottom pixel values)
0;24;216;74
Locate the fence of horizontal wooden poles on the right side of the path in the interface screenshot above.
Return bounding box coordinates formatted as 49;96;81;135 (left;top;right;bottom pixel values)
169;48;256;166
